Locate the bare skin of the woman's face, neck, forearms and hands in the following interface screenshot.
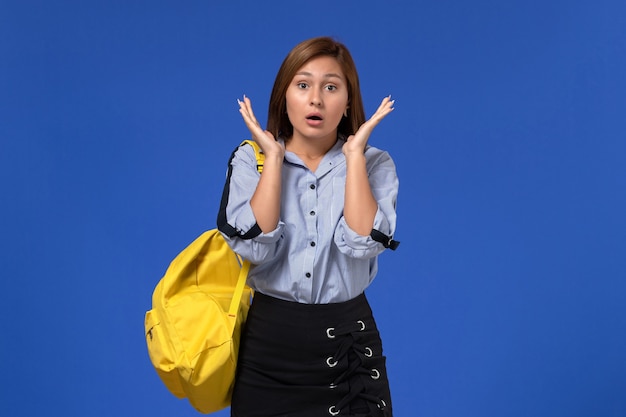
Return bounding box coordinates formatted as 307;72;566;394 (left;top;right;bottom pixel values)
237;56;394;236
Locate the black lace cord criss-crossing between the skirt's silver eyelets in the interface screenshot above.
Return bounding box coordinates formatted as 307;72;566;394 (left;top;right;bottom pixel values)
326;320;388;416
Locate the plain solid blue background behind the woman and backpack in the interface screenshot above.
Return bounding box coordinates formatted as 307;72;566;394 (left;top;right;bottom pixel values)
0;0;626;417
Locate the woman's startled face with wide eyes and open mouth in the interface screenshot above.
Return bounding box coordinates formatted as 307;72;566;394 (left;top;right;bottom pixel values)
285;56;348;140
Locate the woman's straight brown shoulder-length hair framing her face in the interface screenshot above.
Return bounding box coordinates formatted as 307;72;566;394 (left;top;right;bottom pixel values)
267;37;365;139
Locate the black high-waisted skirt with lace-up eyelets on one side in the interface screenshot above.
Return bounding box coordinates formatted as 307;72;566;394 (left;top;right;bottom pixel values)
231;293;392;417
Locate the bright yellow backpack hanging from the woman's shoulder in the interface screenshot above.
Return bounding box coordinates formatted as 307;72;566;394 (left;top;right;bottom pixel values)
145;141;263;413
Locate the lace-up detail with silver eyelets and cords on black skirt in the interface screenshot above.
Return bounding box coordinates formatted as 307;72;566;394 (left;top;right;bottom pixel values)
326;320;391;417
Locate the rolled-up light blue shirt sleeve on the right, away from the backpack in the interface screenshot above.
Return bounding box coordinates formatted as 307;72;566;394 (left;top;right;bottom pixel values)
334;148;399;259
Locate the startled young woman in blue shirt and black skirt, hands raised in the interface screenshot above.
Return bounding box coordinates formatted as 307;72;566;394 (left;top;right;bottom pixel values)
218;37;398;417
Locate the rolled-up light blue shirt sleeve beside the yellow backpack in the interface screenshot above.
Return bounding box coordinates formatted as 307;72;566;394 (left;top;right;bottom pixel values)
218;146;284;264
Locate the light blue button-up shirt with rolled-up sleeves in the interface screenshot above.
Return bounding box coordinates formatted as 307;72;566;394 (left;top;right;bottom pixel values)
220;139;398;304
